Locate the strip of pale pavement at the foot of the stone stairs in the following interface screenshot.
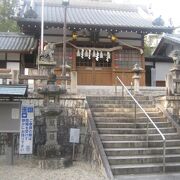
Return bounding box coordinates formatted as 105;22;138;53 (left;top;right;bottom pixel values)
115;173;180;180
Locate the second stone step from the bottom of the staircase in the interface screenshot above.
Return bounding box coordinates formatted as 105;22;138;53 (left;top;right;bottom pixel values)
108;154;180;165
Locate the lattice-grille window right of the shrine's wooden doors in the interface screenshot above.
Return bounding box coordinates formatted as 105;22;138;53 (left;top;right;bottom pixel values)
114;50;142;69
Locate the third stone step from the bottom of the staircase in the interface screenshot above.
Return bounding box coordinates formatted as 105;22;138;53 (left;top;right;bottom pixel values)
104;146;180;156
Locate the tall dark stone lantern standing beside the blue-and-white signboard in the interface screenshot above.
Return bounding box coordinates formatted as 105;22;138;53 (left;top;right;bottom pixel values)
38;73;66;169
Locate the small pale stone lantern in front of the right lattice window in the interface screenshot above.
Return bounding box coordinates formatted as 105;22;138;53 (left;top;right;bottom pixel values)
132;64;143;94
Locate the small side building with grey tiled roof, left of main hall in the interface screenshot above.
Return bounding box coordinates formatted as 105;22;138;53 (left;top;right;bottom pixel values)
0;32;37;84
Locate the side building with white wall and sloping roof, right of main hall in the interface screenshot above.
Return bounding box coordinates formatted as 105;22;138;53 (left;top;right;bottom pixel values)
145;34;180;86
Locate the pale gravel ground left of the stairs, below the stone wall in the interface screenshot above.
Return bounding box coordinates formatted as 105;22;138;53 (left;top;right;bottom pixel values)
0;156;105;180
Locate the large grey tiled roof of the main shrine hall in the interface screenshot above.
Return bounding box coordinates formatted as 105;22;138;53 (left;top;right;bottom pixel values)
16;3;173;32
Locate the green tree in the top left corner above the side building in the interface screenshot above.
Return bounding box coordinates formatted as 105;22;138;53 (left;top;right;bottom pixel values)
0;0;19;32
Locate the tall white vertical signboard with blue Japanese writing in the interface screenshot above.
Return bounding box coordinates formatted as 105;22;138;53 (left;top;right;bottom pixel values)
19;104;34;154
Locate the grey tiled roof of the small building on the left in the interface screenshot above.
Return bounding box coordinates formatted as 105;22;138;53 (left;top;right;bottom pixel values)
0;32;37;52
